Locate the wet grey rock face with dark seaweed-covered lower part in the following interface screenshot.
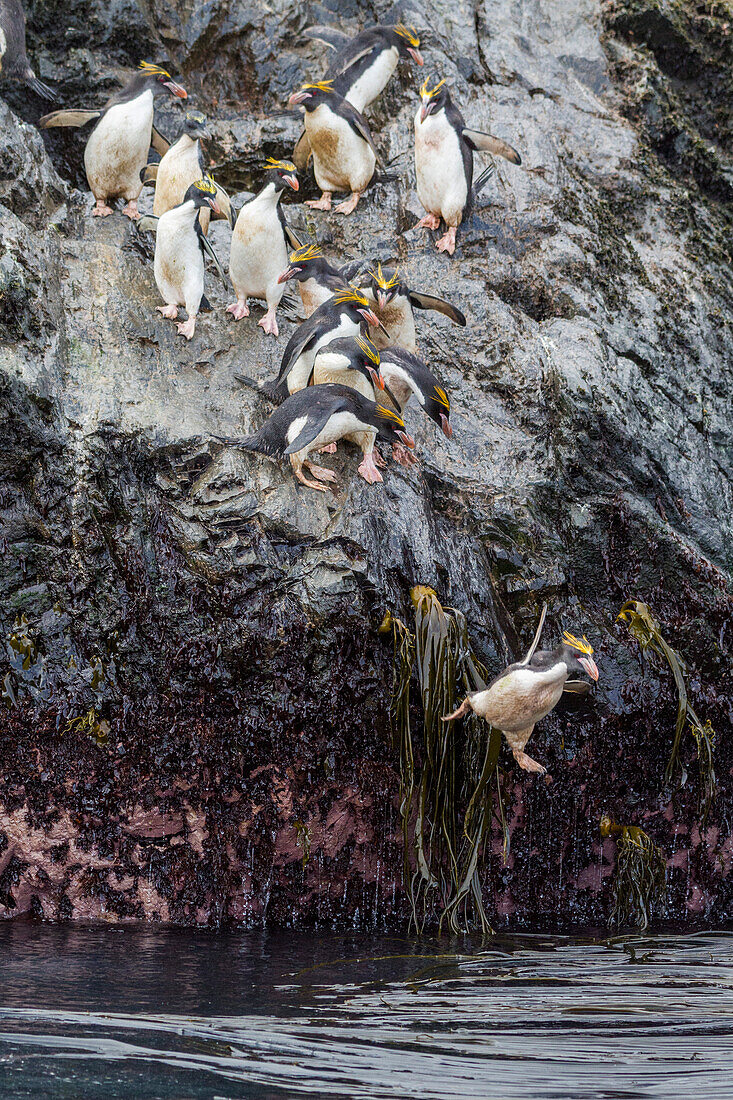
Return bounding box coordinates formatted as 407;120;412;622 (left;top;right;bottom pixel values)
0;0;733;927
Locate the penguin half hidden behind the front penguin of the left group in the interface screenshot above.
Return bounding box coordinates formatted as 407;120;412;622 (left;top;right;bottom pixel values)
142;111;234;233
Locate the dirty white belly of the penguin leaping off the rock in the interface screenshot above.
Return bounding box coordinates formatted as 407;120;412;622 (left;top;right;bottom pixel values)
471;664;567;744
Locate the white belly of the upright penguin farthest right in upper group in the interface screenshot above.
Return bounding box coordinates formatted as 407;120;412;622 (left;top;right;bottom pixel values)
415;111;468;227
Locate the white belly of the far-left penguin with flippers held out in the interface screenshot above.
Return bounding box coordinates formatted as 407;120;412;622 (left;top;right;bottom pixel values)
84;88;153;200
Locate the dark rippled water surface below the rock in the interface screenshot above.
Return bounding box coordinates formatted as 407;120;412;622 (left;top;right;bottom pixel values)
0;923;733;1100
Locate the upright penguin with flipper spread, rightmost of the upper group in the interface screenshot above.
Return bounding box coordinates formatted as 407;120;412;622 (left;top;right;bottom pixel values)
415;80;522;255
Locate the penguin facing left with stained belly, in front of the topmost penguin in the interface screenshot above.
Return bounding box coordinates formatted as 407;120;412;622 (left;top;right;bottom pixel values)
288;80;376;213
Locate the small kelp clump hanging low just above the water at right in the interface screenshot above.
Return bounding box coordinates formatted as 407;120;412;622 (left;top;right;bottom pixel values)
601;814;667;932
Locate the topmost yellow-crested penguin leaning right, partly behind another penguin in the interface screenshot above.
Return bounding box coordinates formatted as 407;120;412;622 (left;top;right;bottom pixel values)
293;23;423;168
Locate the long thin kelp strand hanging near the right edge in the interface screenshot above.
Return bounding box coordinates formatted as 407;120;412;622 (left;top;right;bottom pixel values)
617;600;715;822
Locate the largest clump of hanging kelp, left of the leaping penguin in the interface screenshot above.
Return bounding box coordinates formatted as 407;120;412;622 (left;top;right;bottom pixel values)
381;585;501;932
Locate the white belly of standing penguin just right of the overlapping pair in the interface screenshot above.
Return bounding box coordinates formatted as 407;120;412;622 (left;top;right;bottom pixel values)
229;199;287;305
